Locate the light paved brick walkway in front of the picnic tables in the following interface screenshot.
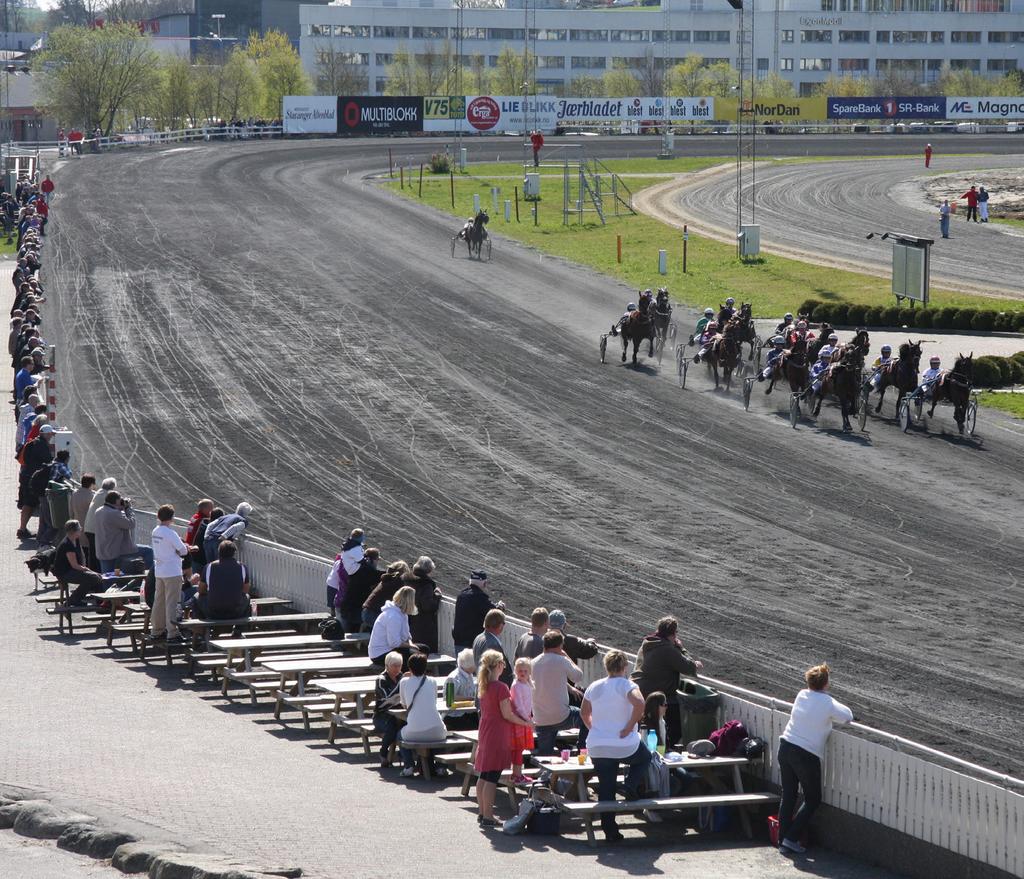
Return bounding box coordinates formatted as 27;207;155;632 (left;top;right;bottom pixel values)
0;418;886;879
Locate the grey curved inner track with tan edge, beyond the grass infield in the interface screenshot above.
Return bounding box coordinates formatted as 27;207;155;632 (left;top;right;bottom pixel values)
655;154;1024;297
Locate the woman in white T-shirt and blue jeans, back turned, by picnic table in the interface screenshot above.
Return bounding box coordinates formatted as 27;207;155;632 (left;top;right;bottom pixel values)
581;651;650;842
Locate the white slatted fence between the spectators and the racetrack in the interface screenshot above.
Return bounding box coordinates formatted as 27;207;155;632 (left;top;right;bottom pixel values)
130;511;1024;877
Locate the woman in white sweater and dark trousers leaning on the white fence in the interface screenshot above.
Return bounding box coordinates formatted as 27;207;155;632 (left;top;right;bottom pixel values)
778;663;853;853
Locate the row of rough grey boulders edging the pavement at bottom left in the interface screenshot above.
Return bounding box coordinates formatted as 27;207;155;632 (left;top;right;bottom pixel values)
0;793;302;879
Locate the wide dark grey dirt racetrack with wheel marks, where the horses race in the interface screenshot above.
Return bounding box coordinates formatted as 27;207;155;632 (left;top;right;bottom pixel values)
46;138;1024;772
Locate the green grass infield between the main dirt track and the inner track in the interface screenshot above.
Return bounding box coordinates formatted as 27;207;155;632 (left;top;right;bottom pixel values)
385;165;1022;316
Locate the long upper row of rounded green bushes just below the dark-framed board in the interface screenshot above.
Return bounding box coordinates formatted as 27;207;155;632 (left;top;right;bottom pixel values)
799;299;1024;333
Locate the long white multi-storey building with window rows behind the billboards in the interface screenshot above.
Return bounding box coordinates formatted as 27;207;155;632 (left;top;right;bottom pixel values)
299;0;1024;95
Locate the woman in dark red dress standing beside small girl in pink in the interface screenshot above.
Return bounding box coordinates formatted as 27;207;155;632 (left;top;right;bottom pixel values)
474;651;526;827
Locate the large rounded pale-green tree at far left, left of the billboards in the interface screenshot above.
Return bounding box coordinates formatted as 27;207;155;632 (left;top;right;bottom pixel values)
36;25;160;135
